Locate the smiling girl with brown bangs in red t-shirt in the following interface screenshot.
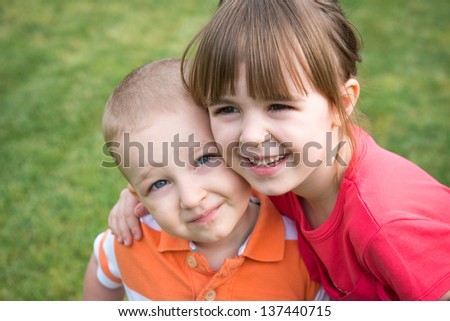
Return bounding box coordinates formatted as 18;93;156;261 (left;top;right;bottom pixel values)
110;0;450;300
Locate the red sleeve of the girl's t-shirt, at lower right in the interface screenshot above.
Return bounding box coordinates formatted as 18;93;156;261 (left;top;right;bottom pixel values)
364;219;450;300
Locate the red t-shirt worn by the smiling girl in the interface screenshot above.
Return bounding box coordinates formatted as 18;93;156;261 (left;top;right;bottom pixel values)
271;131;450;300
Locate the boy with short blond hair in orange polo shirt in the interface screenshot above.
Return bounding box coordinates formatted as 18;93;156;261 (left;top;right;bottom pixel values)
83;59;321;300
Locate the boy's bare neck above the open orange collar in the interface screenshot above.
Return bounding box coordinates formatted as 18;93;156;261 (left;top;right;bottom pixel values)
195;202;259;271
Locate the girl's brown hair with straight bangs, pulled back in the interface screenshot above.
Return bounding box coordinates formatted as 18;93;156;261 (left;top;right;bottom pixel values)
182;0;361;141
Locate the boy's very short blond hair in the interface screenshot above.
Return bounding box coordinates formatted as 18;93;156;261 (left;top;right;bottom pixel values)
102;59;191;165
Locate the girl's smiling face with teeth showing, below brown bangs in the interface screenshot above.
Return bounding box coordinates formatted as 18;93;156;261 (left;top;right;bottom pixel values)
208;65;339;196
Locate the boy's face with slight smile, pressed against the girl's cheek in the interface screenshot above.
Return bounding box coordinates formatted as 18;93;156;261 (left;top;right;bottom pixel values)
122;102;251;243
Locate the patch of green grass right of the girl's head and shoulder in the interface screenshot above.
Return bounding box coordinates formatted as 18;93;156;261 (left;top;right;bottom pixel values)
345;0;450;185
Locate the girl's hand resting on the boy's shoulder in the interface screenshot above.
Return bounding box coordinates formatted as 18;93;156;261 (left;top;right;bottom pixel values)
108;188;148;246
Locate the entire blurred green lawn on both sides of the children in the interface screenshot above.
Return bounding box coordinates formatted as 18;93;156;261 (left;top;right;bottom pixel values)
0;0;450;300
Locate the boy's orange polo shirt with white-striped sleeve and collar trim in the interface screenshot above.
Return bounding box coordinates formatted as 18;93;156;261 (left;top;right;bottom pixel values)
94;195;320;301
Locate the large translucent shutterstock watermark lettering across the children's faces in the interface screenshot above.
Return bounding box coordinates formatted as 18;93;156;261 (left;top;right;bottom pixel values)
100;132;348;168
